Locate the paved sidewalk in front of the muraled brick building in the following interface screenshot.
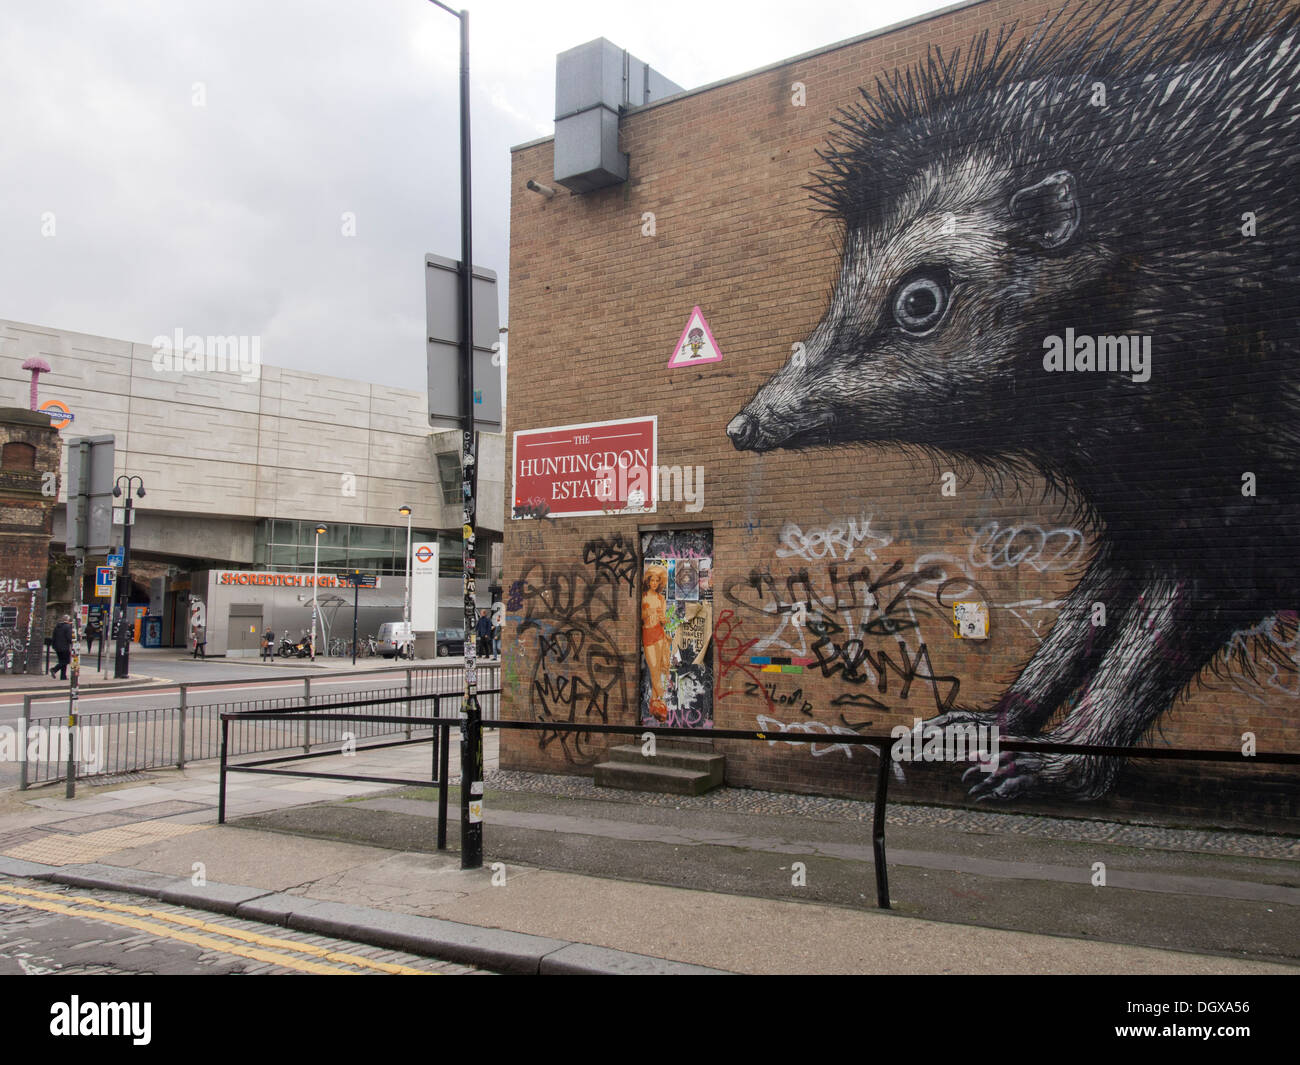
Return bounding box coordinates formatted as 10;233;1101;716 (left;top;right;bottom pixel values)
0;731;1300;974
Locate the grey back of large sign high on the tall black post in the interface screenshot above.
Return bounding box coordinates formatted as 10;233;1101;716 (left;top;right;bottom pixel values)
424;255;502;433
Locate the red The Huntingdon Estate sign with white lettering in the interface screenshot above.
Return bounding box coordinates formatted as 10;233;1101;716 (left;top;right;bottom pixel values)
511;415;659;519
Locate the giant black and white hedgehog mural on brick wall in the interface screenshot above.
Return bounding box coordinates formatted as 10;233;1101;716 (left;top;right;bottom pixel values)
727;0;1300;800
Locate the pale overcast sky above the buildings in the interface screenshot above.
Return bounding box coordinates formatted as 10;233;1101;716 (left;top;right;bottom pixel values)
0;0;944;390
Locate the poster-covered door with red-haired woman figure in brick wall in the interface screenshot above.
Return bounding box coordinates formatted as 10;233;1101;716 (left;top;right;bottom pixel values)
641;529;714;728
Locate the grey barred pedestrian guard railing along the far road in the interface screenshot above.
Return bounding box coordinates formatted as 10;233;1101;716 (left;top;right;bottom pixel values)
18;663;501;789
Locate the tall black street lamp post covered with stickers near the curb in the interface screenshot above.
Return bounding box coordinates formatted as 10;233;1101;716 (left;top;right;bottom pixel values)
429;0;484;869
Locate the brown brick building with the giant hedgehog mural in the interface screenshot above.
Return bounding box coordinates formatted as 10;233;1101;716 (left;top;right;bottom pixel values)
502;0;1300;827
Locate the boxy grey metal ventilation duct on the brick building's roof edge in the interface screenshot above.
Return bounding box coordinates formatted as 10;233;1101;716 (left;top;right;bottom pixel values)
555;36;683;192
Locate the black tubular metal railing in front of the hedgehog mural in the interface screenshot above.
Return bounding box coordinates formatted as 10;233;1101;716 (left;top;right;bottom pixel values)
217;689;1300;910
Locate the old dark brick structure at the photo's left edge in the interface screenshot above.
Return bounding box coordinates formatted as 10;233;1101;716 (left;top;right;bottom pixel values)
0;407;60;672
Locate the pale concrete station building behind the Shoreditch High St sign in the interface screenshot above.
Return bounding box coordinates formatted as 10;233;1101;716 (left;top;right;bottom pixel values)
0;320;504;654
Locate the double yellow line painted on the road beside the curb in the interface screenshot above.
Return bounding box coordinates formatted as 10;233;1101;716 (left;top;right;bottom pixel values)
0;884;437;977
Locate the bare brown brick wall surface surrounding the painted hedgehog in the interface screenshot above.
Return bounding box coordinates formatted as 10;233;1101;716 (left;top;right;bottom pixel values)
502;0;1300;828
